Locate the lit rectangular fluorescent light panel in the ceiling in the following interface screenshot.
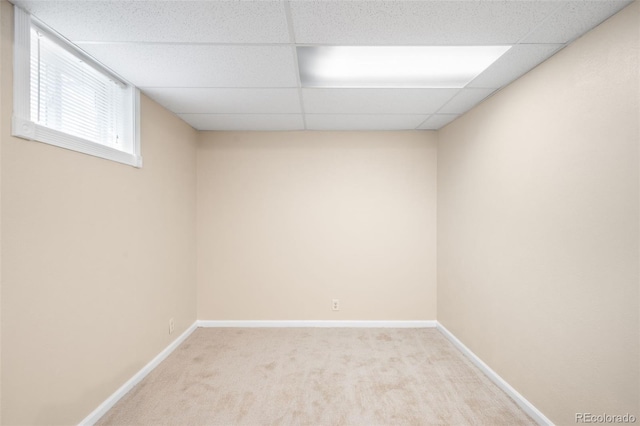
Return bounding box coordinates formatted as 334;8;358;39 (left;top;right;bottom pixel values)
297;46;511;88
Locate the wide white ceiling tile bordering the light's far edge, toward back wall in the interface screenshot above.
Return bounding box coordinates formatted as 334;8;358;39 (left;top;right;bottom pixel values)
302;89;459;114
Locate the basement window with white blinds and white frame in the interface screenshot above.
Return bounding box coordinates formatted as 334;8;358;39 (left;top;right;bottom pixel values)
13;8;142;167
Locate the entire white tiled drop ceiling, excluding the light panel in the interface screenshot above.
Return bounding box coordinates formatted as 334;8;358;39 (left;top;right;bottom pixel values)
13;0;631;130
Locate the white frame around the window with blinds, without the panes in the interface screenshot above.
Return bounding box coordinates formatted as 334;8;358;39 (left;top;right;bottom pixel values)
11;7;142;168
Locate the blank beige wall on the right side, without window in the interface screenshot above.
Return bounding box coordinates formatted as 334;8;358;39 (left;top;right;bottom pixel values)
438;2;640;424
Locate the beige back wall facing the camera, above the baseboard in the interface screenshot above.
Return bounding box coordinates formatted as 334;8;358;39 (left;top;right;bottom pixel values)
198;131;437;320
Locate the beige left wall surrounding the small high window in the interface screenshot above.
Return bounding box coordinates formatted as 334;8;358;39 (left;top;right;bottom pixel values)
1;1;196;425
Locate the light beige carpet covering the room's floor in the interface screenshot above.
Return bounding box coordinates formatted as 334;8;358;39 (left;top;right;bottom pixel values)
97;328;535;426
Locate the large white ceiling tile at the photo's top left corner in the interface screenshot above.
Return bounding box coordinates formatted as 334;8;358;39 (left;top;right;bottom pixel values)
16;0;290;43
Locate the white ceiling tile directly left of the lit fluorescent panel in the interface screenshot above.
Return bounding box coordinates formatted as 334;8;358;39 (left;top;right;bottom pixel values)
80;43;297;87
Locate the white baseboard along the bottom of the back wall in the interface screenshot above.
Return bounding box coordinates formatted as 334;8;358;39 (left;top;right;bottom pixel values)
197;320;437;328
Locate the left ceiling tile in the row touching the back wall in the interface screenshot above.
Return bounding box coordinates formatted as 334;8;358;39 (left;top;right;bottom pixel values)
178;114;304;131
